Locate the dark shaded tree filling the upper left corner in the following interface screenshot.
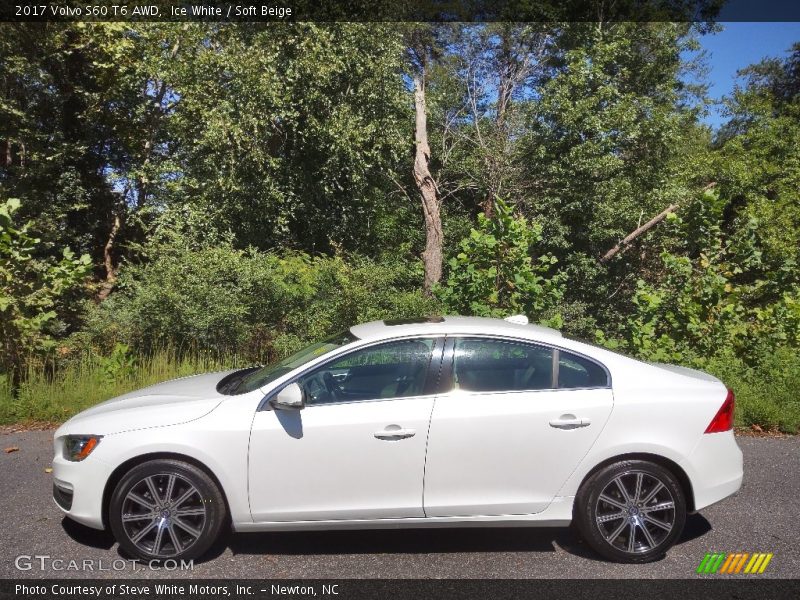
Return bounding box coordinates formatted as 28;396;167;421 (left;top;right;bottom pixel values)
0;23;135;262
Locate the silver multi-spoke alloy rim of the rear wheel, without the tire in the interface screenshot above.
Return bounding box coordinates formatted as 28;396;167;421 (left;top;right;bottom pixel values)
595;471;675;554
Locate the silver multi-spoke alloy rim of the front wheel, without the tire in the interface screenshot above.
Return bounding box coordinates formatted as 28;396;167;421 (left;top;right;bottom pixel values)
121;473;206;558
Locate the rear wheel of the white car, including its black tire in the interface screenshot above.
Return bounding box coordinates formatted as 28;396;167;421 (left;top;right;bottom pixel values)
574;460;686;563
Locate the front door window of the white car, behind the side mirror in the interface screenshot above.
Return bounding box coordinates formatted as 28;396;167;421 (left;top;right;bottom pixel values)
298;338;433;405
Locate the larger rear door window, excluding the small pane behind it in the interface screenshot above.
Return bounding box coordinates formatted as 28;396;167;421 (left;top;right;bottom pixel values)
453;338;553;392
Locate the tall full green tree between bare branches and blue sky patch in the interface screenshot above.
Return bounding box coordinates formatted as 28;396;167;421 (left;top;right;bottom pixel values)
519;23;712;333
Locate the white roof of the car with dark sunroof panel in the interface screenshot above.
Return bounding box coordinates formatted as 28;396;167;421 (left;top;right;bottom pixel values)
350;315;561;341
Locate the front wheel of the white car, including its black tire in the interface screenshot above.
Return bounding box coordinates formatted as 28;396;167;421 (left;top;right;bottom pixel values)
108;459;227;561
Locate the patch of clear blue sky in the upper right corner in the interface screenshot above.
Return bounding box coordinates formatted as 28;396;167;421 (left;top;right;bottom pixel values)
700;21;800;129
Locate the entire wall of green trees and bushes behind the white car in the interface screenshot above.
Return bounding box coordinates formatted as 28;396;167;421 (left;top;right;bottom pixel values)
0;22;800;431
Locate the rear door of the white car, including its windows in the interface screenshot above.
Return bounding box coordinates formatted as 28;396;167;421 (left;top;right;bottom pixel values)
424;337;613;517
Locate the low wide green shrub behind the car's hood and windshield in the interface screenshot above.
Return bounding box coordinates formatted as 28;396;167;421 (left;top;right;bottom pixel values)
76;245;438;361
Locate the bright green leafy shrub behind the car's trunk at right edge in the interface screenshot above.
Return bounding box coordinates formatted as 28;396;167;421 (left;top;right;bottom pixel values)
624;190;800;366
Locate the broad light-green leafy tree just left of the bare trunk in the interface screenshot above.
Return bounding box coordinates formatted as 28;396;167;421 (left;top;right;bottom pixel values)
151;23;408;253
